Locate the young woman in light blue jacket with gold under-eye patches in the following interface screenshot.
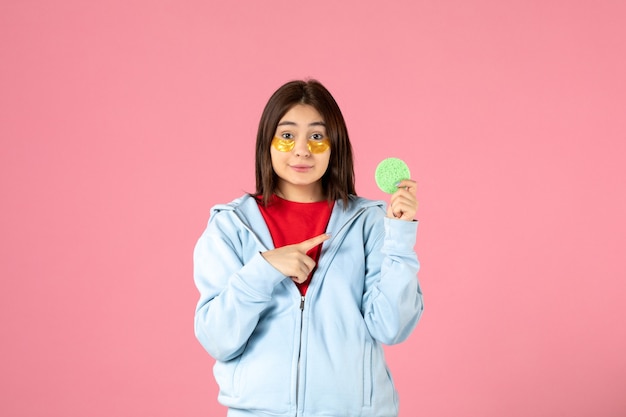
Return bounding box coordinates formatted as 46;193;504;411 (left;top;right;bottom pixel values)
194;80;423;417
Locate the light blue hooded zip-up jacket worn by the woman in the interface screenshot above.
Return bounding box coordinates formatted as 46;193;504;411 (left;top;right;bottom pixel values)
194;195;423;417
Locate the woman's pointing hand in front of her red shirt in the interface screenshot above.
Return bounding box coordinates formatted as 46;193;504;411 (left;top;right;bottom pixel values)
261;233;330;284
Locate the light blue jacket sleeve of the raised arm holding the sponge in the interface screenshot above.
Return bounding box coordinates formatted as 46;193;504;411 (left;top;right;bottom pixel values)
362;211;424;345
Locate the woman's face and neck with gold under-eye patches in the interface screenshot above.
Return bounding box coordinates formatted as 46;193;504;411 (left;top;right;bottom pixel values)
270;104;331;202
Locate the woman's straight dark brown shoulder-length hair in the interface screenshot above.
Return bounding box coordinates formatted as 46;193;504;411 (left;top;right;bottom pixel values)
254;80;356;207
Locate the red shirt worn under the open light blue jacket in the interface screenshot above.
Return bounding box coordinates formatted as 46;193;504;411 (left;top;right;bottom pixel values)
257;195;334;295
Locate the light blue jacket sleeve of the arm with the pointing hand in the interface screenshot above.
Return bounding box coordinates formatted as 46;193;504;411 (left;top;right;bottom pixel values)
193;213;285;361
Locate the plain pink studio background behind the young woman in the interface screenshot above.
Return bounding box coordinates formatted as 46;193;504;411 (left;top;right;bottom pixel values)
0;0;626;417
